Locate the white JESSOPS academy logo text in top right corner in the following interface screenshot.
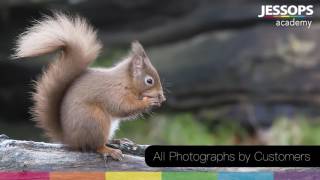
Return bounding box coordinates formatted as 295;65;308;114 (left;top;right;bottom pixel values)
258;5;313;28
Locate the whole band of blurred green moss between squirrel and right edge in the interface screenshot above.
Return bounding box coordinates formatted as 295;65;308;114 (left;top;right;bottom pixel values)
117;113;320;145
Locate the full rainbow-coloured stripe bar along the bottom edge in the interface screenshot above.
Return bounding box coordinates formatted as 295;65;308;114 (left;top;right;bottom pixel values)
0;170;320;180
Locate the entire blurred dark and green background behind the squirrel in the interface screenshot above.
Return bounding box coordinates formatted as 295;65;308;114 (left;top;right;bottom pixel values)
0;0;320;145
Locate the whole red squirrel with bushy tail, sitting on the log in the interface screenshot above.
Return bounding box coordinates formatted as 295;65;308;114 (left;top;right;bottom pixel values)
13;13;166;160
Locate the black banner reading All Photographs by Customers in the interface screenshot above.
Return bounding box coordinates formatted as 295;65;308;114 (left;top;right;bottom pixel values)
145;145;320;167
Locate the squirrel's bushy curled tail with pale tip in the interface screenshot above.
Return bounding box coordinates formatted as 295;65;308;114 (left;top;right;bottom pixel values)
13;13;101;141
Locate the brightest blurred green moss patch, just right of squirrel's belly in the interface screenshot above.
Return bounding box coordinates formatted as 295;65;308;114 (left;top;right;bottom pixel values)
117;113;212;144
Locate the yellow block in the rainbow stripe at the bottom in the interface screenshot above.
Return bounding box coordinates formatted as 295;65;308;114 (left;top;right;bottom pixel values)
106;171;161;180
